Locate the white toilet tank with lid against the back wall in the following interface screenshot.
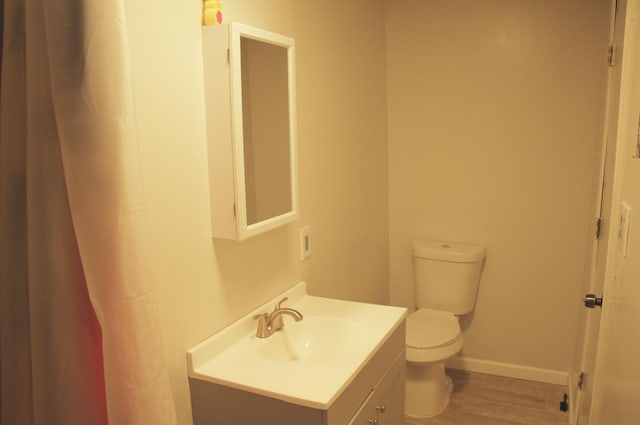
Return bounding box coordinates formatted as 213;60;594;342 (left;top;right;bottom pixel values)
413;240;486;315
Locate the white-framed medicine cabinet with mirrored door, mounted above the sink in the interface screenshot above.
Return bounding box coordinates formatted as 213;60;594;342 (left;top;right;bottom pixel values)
202;22;298;240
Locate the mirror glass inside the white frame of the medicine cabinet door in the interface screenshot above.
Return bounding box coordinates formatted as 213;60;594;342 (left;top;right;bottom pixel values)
240;36;293;226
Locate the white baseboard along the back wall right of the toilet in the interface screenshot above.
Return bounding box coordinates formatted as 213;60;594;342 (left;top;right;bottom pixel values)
447;356;569;385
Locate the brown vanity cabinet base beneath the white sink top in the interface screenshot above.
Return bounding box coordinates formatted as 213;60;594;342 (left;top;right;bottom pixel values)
189;321;405;425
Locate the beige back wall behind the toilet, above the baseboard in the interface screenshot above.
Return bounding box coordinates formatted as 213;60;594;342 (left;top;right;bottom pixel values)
386;0;609;371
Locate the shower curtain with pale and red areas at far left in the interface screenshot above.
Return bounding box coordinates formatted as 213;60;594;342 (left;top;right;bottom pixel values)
0;0;176;425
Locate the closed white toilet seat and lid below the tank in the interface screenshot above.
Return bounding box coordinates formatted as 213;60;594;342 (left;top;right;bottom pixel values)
406;308;463;363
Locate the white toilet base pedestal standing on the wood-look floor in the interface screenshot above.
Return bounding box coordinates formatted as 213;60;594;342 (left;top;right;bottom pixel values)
404;361;453;419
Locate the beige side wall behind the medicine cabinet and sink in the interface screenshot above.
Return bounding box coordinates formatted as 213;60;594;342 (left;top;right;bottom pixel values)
126;0;388;425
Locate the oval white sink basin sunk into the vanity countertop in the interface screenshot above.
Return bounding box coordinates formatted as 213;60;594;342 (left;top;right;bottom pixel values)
256;315;362;366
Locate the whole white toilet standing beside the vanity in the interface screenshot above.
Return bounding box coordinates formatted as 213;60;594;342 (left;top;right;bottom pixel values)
405;240;486;418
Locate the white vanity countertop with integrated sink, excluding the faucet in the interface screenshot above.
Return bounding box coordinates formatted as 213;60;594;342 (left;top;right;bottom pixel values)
187;282;406;423
